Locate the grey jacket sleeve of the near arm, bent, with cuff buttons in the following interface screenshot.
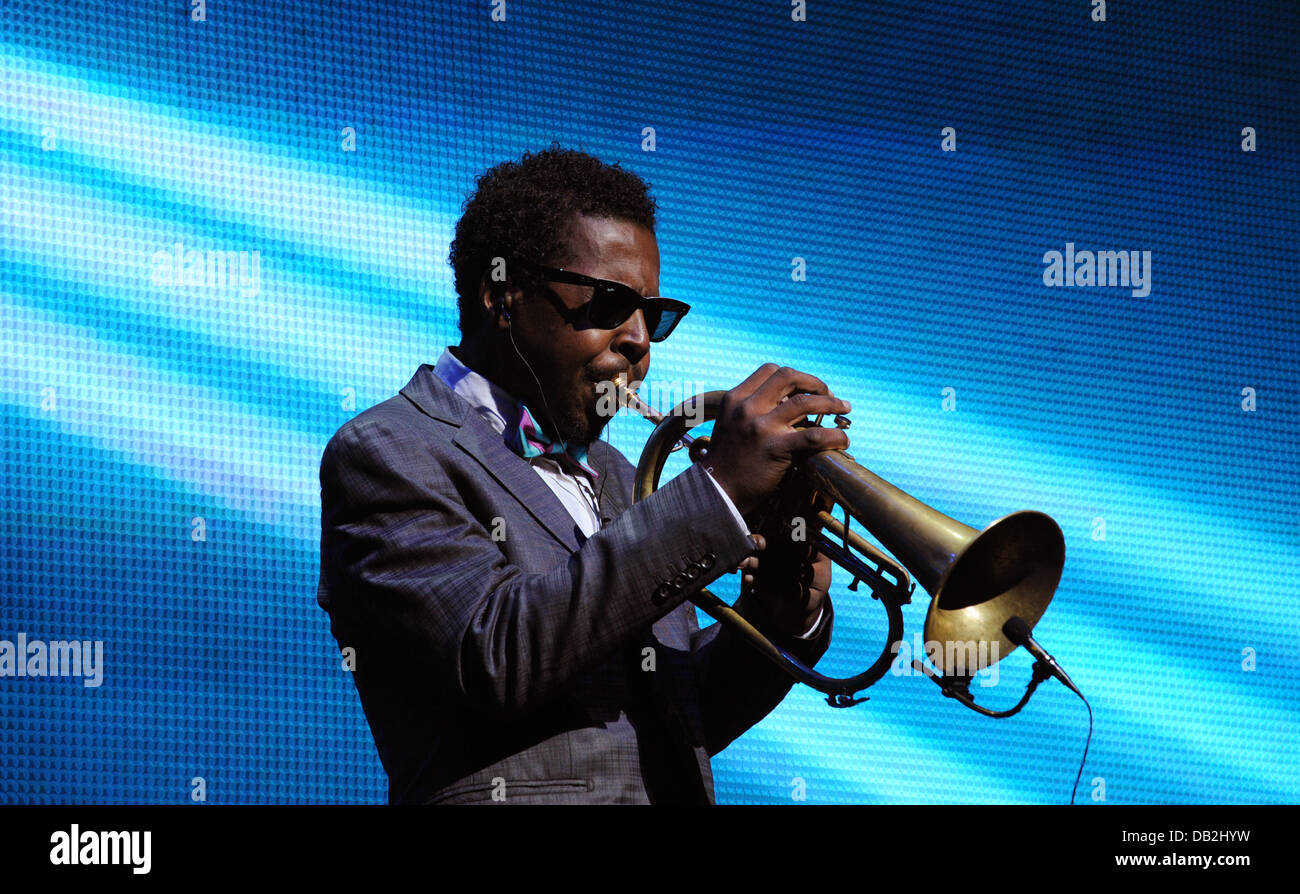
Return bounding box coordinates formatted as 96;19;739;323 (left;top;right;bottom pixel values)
321;420;751;713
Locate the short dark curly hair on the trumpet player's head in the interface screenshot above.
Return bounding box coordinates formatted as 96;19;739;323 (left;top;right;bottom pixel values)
447;143;655;334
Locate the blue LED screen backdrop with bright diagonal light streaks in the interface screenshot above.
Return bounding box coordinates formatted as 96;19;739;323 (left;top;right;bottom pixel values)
0;0;1300;806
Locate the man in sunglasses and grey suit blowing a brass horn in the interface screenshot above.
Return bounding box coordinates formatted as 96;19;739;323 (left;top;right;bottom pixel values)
319;147;849;803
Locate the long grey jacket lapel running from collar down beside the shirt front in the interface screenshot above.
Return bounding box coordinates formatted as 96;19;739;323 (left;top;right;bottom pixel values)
402;364;579;551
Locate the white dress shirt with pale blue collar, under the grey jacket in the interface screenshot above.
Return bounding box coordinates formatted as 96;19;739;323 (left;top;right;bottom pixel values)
433;348;826;639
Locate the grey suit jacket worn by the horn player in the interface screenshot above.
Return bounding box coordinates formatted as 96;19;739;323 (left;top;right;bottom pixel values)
317;364;832;803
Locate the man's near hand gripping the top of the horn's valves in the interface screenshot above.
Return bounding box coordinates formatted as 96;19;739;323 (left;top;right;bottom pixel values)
709;364;850;515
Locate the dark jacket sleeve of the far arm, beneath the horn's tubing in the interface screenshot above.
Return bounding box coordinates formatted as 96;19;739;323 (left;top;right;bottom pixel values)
689;596;835;756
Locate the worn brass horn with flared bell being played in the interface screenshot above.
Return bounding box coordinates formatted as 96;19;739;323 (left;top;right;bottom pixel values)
616;381;1065;717
